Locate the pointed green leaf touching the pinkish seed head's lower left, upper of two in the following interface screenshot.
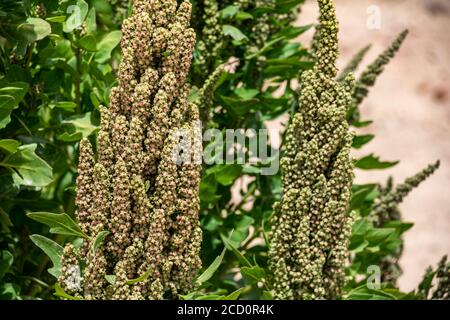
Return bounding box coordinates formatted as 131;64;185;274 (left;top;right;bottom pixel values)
27;212;89;239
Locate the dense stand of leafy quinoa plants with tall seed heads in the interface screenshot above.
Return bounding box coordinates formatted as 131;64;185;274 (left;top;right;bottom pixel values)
0;0;449;300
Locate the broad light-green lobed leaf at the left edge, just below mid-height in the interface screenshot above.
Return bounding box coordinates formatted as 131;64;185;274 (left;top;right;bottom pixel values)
0;144;53;187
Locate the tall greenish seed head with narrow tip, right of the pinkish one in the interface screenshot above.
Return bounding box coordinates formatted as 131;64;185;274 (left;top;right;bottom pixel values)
269;0;354;299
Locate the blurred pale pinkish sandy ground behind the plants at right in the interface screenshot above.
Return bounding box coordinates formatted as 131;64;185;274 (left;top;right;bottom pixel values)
297;0;450;290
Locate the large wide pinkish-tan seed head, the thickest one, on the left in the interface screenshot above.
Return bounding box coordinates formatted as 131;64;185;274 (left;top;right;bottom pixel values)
61;0;202;299
